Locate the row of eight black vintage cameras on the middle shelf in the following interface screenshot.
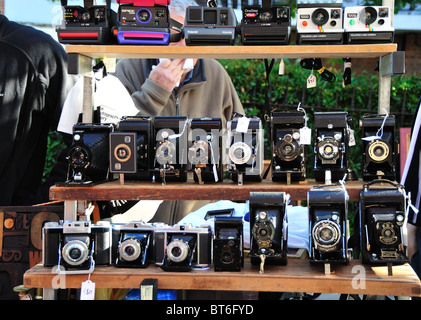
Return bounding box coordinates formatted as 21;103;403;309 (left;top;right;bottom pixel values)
59;112;399;186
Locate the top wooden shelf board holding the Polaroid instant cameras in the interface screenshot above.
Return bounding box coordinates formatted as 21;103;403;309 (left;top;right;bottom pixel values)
66;43;397;59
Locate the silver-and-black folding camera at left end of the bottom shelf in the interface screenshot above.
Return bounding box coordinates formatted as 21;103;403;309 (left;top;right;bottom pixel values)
42;221;111;273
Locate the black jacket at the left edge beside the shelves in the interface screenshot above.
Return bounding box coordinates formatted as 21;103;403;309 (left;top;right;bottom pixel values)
0;14;67;206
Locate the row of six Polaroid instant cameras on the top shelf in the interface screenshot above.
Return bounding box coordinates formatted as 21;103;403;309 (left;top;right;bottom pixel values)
57;0;394;46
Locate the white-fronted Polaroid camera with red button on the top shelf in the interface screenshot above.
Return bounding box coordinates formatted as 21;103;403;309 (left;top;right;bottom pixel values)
297;0;344;45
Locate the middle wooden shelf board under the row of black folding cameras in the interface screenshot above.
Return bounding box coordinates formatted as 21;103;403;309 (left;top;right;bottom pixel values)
50;180;363;201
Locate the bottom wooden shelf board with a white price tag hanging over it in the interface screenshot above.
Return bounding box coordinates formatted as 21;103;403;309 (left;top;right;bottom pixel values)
23;258;421;296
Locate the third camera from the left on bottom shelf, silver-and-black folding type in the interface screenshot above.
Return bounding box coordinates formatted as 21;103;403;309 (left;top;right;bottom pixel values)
155;224;212;271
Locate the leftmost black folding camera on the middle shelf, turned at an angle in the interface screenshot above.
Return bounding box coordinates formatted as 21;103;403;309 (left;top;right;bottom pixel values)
58;123;114;186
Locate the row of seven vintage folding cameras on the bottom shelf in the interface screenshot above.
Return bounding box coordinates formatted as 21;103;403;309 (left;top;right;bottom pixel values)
42;179;408;273
